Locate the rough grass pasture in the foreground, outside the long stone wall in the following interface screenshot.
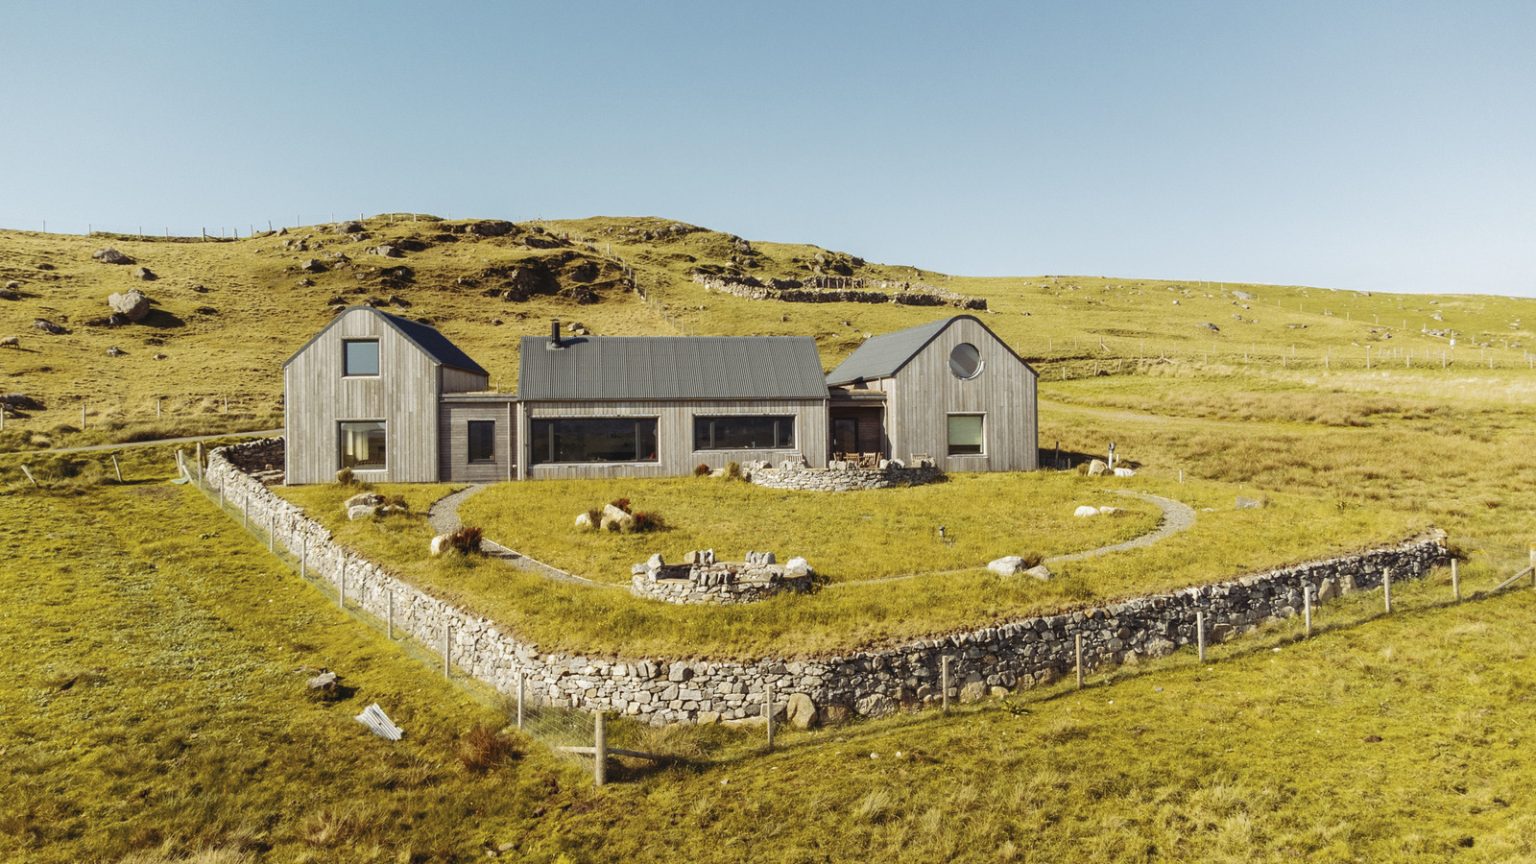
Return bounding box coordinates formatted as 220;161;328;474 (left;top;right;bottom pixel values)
0;477;1536;864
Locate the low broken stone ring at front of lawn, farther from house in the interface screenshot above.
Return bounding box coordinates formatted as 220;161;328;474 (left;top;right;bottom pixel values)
630;549;813;606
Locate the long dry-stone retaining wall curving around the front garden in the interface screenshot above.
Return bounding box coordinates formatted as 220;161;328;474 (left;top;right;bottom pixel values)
207;441;1447;724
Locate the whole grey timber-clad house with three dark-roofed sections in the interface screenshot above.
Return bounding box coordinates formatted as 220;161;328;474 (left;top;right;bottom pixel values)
283;306;1038;484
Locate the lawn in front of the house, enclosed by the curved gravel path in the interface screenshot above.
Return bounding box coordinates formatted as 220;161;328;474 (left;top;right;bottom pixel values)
461;474;1161;584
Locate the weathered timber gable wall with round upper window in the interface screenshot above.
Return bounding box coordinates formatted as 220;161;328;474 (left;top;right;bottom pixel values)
880;318;1040;472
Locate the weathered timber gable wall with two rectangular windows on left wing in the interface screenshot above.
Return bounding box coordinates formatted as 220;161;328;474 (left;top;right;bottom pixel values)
283;309;439;484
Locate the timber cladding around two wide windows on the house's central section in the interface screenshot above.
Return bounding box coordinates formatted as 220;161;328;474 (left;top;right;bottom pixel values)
518;400;829;480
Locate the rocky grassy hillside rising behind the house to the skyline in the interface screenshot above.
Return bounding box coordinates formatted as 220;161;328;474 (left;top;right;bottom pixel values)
0;215;1536;449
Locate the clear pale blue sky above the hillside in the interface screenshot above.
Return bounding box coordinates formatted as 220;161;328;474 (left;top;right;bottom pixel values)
0;0;1536;295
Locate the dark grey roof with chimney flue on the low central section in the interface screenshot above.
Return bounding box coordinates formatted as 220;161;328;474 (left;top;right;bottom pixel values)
518;337;826;401
